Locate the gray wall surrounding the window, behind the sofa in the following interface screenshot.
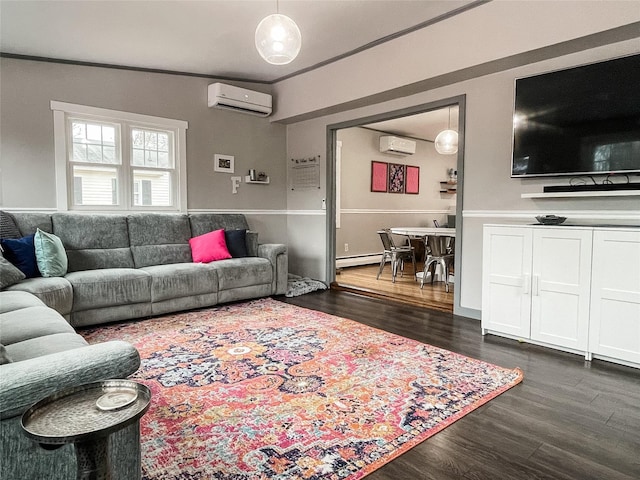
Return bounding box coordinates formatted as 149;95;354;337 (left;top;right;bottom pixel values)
0;58;286;242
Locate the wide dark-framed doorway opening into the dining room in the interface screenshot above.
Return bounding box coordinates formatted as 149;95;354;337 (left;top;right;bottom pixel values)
327;96;465;312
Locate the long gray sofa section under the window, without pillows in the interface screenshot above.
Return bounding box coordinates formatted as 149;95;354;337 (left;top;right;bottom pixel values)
6;212;288;327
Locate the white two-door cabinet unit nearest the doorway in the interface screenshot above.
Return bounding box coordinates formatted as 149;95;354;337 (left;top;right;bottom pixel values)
482;226;592;357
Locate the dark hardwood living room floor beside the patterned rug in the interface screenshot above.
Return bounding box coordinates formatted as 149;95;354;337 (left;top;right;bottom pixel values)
279;290;640;480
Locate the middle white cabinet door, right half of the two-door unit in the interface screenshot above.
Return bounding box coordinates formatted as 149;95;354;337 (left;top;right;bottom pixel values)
531;227;592;351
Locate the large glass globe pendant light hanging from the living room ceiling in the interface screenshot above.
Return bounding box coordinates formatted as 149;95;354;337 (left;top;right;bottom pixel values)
256;13;302;65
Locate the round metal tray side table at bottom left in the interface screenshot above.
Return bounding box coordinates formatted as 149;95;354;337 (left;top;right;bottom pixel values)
22;380;151;480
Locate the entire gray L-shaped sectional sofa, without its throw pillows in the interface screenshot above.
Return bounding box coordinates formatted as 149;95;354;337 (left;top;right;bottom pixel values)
0;213;287;480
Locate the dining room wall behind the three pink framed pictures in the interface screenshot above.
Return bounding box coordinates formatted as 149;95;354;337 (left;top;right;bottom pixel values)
336;127;457;258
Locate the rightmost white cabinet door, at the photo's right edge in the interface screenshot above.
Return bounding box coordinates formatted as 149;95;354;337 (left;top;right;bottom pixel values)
589;230;640;363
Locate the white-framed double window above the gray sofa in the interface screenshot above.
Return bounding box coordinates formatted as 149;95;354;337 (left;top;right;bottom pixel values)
51;102;187;211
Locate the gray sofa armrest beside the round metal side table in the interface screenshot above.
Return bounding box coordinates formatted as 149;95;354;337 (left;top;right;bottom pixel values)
0;340;140;419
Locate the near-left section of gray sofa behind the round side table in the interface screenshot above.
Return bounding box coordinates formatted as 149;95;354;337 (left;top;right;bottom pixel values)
0;291;141;480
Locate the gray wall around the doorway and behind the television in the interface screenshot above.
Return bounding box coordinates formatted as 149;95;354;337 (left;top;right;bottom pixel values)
287;39;640;317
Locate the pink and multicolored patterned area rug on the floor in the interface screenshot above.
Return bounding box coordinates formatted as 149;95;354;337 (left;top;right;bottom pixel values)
81;299;522;480
